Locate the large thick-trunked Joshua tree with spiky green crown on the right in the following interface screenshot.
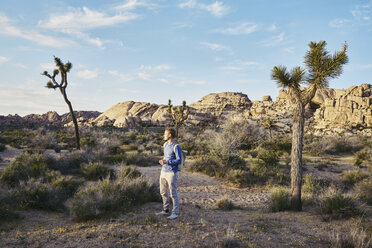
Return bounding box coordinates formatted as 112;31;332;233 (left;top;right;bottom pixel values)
271;41;348;211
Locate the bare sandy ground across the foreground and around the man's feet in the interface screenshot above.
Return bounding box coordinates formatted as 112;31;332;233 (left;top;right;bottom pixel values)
0;151;360;247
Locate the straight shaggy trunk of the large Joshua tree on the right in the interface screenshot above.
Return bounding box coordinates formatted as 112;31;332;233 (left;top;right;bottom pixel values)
291;101;305;211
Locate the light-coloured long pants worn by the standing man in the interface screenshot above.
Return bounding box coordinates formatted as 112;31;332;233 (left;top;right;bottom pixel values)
159;171;180;215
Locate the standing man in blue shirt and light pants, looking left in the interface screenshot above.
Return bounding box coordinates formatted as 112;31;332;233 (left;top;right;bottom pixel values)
156;128;182;220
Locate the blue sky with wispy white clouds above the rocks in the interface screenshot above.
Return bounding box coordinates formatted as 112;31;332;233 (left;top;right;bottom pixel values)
0;0;372;116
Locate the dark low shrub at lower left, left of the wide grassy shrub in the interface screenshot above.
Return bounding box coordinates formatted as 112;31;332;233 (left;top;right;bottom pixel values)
9;178;63;210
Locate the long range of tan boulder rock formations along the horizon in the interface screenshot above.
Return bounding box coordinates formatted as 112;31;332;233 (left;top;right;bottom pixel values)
0;84;372;136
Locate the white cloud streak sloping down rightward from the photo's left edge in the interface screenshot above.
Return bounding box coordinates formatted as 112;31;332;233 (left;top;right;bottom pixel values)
0;15;75;48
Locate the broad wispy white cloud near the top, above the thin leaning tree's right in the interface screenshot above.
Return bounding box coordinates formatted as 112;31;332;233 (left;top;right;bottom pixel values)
39;7;139;32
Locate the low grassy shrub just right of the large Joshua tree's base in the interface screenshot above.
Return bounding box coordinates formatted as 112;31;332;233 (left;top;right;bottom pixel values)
318;186;360;219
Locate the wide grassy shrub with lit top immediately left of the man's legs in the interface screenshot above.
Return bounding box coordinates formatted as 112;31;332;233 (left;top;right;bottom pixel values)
68;177;159;221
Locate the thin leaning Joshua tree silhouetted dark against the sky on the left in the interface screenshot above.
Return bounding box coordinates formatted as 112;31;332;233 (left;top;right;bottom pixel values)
42;56;80;149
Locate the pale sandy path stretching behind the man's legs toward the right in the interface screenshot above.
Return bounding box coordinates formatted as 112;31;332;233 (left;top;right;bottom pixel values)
138;166;269;209
